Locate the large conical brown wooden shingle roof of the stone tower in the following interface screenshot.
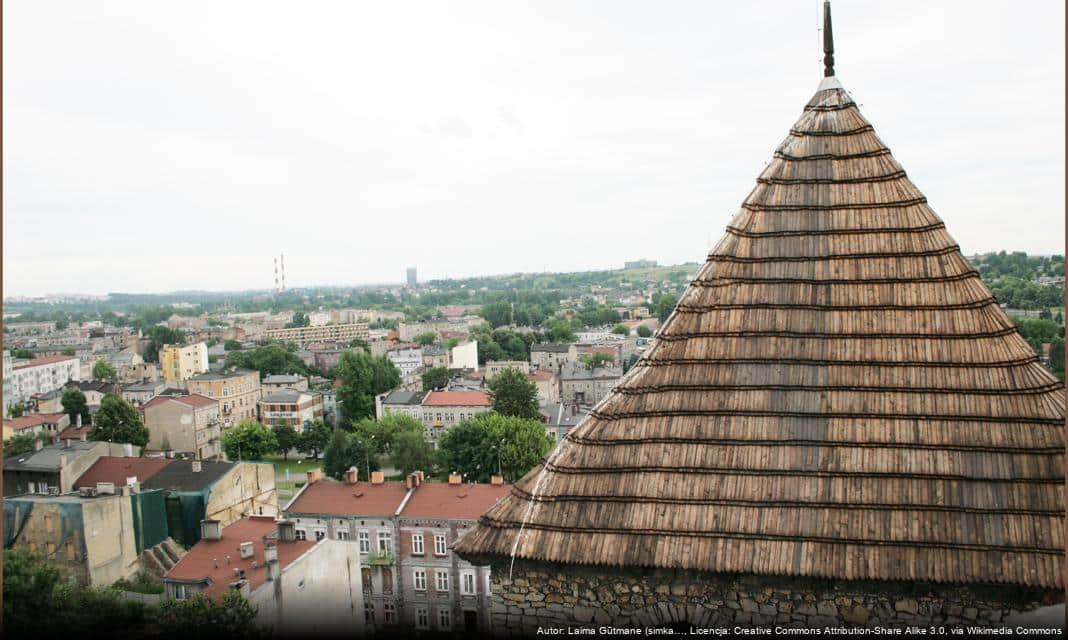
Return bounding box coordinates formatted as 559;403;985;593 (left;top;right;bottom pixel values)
457;76;1065;588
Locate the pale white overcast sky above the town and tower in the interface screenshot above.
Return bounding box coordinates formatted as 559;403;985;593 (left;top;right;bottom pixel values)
3;0;1065;296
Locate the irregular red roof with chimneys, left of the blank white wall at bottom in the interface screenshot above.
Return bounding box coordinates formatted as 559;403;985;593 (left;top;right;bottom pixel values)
167;516;315;597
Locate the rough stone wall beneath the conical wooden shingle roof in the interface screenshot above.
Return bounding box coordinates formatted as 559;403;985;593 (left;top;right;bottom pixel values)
491;560;1064;636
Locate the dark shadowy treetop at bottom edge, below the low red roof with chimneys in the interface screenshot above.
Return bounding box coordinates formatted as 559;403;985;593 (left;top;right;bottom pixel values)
157;589;261;638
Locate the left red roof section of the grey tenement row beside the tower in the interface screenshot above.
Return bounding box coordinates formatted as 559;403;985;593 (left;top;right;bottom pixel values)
285;480;408;517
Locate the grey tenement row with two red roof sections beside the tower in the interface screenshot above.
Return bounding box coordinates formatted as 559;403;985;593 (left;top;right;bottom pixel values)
284;469;511;634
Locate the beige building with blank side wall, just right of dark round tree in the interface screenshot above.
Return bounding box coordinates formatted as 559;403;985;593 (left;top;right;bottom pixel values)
141;393;222;459
